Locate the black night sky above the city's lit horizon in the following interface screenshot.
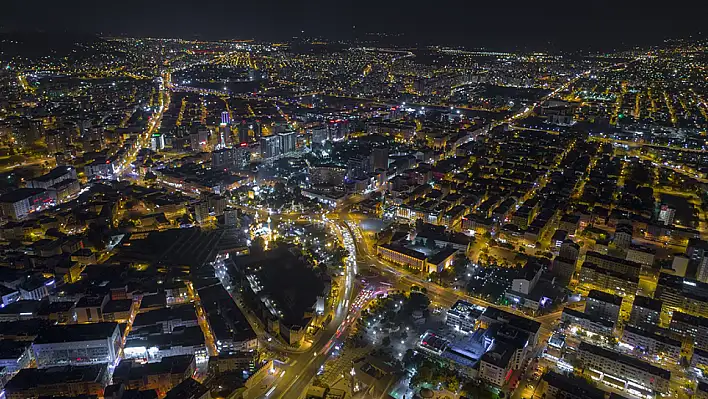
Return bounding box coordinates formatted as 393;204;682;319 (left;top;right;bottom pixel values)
0;0;708;51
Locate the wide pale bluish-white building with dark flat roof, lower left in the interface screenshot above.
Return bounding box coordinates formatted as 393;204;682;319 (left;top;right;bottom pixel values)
32;322;122;368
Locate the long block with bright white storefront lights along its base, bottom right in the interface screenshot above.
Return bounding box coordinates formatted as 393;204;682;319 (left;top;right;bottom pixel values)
577;342;671;397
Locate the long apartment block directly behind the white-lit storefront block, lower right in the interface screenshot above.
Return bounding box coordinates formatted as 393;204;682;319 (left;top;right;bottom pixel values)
621;326;681;364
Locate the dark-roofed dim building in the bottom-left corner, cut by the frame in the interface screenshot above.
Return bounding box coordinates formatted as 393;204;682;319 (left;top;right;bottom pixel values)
5;364;111;399
